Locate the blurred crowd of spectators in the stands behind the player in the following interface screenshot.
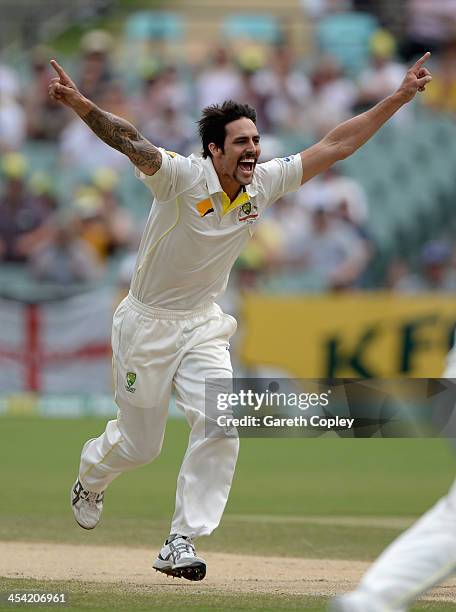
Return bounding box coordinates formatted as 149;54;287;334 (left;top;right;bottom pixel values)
0;0;456;291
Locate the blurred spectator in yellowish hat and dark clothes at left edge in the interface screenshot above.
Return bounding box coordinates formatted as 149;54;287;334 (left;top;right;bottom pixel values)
0;153;52;263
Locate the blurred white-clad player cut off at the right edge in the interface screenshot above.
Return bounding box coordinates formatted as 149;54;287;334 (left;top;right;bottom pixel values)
330;352;456;612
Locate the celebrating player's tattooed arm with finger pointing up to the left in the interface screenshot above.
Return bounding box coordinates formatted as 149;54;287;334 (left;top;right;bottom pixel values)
49;60;162;175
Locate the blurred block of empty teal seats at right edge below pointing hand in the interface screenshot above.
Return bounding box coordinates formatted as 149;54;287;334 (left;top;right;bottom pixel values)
343;110;456;262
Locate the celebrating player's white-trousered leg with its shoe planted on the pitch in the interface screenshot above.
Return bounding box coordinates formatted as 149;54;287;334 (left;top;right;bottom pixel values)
154;312;239;580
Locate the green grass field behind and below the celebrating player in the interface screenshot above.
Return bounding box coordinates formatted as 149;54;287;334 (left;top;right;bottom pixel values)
0;417;456;612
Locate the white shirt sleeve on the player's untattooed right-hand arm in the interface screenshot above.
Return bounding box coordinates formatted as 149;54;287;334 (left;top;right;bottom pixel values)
257;153;302;205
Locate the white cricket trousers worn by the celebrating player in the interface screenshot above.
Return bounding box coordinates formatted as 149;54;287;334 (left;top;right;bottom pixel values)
75;294;239;537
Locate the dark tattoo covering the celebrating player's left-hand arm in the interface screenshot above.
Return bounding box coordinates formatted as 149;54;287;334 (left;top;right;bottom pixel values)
81;108;162;172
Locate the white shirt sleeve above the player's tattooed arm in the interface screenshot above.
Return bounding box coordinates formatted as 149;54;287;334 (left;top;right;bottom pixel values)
135;148;198;202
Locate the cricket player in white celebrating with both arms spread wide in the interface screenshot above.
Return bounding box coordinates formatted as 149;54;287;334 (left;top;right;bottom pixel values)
49;53;432;580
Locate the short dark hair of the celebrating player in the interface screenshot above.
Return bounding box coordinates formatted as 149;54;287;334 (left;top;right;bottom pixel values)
198;100;256;157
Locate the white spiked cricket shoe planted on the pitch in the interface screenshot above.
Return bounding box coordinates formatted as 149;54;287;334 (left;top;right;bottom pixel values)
153;533;206;580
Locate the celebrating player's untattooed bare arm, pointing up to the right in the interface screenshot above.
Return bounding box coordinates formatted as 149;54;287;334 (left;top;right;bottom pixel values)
301;52;432;184
